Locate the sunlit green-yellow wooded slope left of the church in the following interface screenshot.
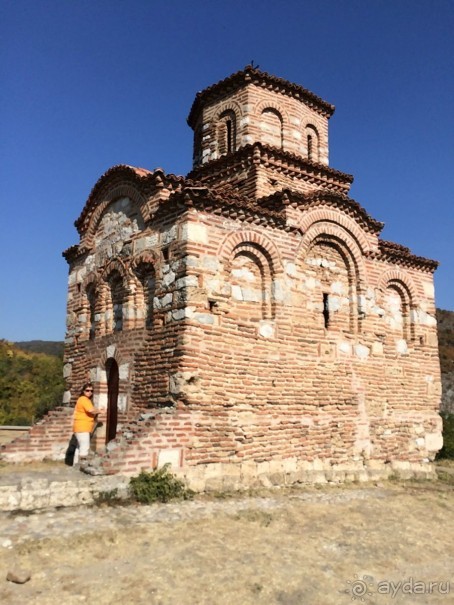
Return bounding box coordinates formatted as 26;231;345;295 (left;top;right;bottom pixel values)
0;340;64;425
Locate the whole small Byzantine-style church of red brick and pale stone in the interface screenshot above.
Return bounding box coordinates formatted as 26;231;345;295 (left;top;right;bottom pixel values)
3;66;442;489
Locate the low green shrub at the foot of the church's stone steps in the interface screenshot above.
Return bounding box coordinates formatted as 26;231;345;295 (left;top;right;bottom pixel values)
129;464;194;504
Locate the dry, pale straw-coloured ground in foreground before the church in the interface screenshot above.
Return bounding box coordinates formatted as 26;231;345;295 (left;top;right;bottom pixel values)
0;476;454;605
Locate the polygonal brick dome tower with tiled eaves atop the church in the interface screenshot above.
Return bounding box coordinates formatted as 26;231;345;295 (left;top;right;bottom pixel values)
188;65;352;198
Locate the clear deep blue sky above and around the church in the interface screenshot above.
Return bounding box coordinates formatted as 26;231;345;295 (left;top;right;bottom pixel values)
0;0;454;341
